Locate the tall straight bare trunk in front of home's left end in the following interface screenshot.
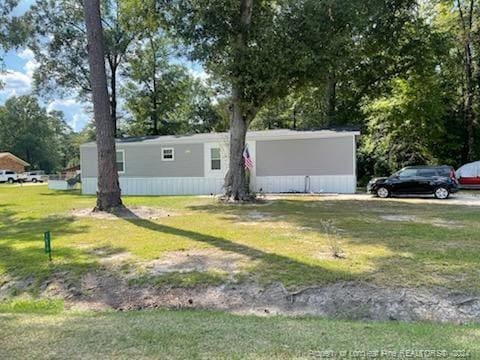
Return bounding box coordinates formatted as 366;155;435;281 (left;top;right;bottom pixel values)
84;0;122;211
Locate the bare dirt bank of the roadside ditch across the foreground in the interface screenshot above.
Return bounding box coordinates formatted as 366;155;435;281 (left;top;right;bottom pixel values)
53;272;480;323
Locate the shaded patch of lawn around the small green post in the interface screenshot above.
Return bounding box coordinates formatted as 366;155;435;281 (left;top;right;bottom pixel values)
0;205;117;299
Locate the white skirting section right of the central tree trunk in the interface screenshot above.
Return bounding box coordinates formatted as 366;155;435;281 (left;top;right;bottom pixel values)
256;175;357;194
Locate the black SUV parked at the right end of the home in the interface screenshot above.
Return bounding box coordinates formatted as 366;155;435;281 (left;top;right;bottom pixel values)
367;165;458;199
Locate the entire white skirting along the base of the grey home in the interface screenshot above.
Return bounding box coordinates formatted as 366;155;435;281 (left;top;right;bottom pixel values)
82;175;357;195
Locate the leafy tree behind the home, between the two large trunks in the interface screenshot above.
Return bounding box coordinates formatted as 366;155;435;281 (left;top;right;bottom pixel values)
122;34;220;135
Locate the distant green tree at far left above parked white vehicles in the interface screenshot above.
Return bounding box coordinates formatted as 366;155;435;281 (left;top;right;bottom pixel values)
0;96;78;172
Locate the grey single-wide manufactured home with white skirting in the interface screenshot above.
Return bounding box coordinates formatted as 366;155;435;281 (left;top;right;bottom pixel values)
80;130;360;195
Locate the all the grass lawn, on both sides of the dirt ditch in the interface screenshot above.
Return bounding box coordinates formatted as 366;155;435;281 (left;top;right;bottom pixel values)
0;185;480;359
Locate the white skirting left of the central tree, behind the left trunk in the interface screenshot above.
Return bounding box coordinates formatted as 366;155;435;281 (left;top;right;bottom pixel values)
82;177;223;195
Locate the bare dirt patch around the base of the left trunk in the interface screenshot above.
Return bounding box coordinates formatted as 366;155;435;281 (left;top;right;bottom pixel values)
71;206;177;220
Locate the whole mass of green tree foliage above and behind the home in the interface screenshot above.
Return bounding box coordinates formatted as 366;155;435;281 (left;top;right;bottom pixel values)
4;0;480;177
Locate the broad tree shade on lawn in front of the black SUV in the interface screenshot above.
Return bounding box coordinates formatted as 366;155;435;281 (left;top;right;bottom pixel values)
186;199;480;292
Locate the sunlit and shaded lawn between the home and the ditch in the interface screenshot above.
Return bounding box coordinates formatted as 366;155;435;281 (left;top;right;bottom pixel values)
0;185;480;295
